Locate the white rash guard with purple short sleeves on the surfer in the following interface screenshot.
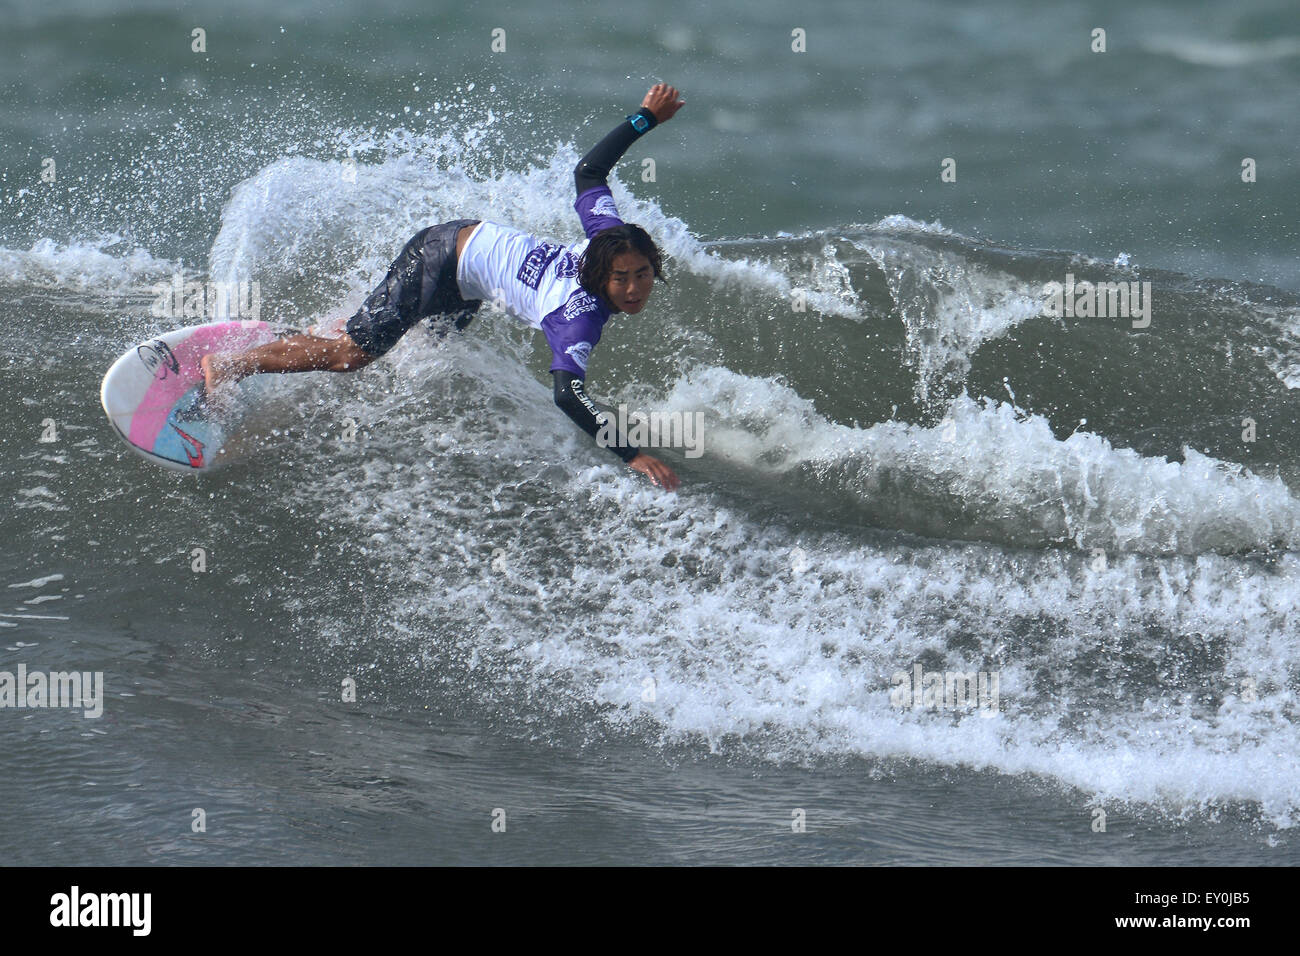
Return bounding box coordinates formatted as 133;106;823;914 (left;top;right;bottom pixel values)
456;186;623;378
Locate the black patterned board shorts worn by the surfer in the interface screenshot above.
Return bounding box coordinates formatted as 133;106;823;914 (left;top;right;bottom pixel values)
347;219;482;355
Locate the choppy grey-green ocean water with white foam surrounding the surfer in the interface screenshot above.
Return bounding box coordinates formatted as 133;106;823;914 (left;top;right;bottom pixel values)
0;0;1300;865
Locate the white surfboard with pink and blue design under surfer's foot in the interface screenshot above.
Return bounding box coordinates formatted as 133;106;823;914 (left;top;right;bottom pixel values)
100;320;294;473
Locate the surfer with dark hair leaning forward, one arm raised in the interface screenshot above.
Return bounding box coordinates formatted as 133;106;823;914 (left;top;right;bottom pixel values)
203;83;685;489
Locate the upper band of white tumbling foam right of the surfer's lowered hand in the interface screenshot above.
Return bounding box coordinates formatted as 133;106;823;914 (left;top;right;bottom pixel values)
664;368;1300;554
